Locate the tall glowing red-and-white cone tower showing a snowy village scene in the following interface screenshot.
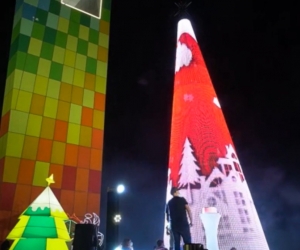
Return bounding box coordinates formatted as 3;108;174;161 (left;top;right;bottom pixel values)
165;19;269;250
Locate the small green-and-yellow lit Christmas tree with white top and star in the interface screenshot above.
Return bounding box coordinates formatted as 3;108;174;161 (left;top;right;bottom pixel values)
7;175;71;250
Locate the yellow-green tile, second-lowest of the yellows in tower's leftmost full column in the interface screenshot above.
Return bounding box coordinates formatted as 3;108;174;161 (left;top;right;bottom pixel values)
6;132;25;158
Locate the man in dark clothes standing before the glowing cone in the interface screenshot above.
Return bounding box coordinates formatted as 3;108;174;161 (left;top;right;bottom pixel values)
166;187;193;250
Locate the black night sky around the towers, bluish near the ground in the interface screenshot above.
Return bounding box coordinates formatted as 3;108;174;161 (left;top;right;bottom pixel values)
1;0;300;250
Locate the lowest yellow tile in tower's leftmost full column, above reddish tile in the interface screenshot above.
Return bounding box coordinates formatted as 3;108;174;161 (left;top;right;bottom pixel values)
3;157;20;183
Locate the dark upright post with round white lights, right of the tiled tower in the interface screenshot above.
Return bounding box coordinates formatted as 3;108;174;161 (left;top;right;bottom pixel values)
106;185;125;250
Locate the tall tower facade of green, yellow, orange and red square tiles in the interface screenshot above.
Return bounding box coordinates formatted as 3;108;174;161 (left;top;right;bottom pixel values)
0;0;110;239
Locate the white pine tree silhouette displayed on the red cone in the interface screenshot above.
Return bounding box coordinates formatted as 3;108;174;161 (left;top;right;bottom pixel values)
178;138;200;203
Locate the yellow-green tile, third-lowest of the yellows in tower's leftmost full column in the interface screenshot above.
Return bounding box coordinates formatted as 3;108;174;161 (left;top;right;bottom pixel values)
8;110;28;135
